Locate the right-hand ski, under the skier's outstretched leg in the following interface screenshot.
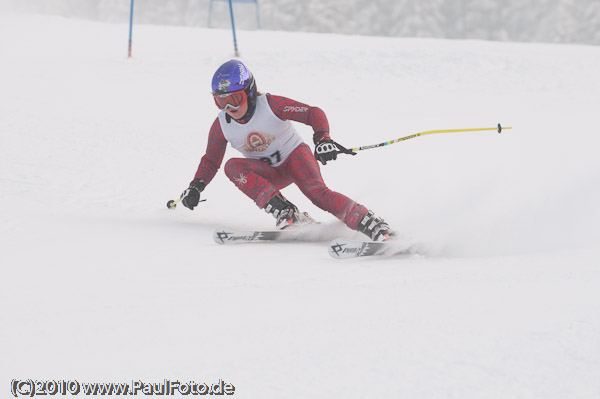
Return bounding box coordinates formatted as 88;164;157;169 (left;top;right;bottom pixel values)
328;238;413;259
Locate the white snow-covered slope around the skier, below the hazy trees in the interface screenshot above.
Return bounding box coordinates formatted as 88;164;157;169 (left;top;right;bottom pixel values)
0;15;600;399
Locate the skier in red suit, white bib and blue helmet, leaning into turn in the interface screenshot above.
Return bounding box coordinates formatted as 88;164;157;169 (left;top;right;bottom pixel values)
181;60;394;241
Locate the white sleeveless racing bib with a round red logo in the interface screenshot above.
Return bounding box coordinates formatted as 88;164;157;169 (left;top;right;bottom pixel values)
219;95;304;166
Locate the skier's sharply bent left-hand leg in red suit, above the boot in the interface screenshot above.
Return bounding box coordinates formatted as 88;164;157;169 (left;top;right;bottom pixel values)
224;158;291;209
